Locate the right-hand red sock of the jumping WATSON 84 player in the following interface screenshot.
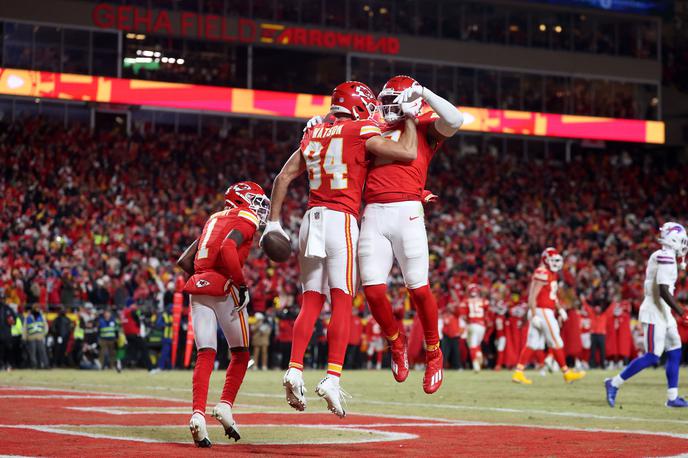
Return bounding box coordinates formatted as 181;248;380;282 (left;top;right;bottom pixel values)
327;289;354;377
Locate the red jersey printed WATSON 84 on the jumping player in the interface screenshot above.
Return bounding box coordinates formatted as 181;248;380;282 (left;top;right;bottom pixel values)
300;119;381;218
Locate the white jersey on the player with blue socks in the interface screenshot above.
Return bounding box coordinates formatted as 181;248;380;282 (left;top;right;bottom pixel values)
639;248;678;326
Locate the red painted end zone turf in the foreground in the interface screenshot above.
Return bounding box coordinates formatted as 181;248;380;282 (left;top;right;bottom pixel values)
0;389;688;457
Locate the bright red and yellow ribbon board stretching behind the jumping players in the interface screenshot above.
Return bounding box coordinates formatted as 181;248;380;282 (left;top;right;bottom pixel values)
0;68;665;144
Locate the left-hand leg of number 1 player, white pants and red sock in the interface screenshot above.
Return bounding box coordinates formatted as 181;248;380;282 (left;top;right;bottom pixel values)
189;295;217;448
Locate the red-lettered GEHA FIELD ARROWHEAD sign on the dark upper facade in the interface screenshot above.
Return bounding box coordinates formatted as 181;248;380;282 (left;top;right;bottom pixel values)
91;3;399;55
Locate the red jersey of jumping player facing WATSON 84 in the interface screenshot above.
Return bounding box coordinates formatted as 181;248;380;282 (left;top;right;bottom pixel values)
364;111;442;204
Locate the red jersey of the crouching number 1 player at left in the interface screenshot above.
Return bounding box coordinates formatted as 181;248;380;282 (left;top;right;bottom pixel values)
194;208;260;277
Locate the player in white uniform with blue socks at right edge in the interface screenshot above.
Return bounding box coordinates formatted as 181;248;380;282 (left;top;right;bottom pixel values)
604;222;688;407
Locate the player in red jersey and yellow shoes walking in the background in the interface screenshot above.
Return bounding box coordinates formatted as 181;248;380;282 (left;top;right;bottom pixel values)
511;248;585;385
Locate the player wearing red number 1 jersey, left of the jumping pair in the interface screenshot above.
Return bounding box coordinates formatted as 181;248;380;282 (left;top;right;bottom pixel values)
177;181;270;447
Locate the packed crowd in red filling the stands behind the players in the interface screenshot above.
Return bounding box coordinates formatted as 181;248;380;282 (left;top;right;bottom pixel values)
0;118;688;370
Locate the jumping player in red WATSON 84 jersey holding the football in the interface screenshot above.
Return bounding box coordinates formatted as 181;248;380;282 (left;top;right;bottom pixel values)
265;81;417;417
